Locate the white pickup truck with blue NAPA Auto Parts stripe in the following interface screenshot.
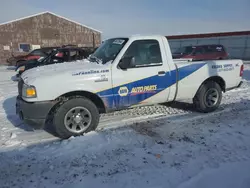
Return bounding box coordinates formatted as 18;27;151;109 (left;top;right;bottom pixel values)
16;36;243;138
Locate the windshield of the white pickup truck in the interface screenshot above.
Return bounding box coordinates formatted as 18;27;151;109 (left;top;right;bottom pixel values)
89;38;128;64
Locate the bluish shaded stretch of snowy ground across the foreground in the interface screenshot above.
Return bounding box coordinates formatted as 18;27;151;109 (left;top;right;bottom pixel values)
0;106;250;188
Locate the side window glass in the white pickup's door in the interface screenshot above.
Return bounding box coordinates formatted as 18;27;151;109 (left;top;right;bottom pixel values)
123;40;162;68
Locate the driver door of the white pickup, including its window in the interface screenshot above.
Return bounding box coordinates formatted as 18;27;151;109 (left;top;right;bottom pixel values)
112;39;169;109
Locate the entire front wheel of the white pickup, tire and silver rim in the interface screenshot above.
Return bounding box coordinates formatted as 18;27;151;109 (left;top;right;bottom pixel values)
53;97;100;139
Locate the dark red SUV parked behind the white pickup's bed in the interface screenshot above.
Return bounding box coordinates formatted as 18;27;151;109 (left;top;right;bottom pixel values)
173;44;228;60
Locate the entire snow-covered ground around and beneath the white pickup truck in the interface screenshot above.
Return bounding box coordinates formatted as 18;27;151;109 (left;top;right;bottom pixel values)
0;65;250;188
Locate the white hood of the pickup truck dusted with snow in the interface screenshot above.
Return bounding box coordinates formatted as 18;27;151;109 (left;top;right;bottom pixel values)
21;59;110;84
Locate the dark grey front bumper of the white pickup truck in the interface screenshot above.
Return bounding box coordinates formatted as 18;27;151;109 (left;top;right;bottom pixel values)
16;96;55;129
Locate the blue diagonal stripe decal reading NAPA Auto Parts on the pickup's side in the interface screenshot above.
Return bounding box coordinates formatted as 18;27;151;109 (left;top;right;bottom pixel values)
97;63;206;109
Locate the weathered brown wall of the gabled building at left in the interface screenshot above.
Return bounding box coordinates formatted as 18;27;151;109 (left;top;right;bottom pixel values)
0;13;101;64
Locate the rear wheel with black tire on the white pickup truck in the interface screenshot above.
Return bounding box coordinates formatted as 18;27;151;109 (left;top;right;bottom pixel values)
193;81;222;113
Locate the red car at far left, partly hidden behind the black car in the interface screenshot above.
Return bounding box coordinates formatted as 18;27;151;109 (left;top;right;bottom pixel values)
7;47;59;66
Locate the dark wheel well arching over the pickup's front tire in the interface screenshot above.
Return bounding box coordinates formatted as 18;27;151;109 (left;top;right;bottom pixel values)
57;91;106;113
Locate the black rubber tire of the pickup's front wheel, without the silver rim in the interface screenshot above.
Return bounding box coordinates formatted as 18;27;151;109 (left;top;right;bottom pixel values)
53;97;100;139
